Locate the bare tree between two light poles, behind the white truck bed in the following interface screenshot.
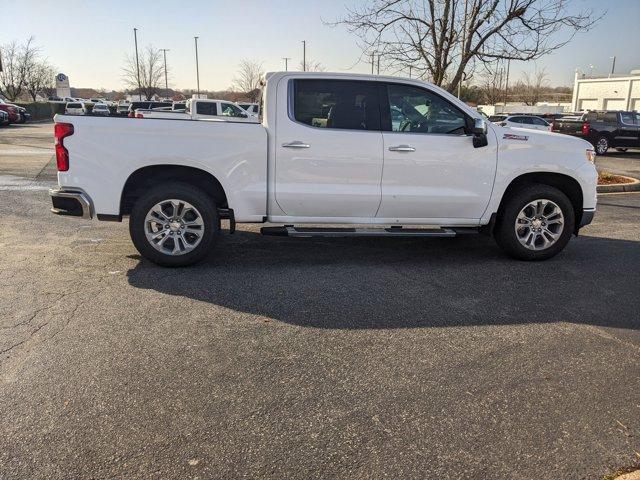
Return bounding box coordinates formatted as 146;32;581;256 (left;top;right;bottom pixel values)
122;45;164;100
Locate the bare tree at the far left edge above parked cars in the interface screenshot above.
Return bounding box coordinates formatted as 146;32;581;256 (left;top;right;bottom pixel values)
0;37;39;101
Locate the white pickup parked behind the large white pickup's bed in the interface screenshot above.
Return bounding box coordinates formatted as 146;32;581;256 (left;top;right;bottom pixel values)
135;98;258;123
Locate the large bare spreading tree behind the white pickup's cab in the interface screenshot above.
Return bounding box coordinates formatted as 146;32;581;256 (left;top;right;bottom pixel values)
332;0;602;91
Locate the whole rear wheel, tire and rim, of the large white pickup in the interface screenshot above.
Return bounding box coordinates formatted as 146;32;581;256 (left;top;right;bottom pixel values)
129;183;220;267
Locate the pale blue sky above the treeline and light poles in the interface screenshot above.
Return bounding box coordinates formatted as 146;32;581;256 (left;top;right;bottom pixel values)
0;0;640;90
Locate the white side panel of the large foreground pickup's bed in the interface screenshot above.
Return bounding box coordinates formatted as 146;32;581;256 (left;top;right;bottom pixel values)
54;115;267;222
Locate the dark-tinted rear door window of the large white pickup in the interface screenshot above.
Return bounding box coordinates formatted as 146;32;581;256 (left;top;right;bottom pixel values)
293;80;380;130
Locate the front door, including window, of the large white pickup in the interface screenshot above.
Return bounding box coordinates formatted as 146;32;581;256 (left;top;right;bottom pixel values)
377;83;497;224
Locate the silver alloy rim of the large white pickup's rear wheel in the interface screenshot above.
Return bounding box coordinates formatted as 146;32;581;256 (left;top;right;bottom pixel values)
144;199;204;255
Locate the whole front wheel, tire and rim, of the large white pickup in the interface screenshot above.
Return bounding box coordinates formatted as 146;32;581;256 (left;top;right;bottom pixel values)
495;184;575;260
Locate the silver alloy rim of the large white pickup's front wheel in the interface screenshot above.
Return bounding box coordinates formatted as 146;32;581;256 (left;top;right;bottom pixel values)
515;199;564;250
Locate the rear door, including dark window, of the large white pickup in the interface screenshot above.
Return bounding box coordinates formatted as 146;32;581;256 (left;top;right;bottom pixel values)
275;77;382;219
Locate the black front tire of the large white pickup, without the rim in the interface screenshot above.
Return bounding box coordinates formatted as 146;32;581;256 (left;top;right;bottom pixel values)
494;183;575;261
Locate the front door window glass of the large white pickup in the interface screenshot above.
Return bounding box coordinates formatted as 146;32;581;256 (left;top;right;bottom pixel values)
388;84;466;135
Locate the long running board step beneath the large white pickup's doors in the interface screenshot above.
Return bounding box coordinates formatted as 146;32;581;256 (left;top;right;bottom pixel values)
260;225;457;237
